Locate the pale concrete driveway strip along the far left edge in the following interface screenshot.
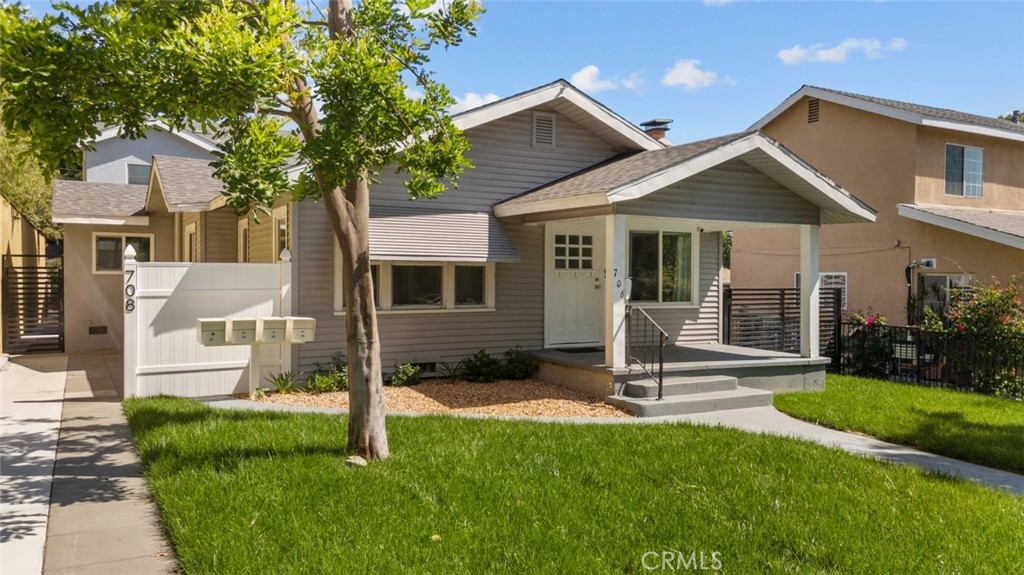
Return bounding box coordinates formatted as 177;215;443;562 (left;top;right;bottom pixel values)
0;355;68;574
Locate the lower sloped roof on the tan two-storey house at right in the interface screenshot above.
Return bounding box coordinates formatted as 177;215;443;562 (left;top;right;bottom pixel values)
896;204;1024;250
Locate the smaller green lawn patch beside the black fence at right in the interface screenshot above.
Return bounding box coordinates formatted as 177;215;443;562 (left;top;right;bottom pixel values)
775;375;1024;473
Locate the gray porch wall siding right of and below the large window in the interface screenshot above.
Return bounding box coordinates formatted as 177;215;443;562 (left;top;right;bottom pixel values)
645;232;722;344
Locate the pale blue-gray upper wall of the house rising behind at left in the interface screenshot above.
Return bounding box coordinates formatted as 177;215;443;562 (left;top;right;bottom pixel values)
84;130;213;184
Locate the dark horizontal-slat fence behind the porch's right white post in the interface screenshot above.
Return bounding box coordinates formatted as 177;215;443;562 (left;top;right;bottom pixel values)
722;288;843;357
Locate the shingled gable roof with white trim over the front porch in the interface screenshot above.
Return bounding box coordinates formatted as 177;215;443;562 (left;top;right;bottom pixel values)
495;130;874;223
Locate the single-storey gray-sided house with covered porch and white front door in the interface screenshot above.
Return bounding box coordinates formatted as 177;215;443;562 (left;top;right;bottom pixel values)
51;80;874;414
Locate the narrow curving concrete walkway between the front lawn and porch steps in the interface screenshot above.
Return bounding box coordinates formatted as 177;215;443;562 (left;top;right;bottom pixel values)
205;396;1024;495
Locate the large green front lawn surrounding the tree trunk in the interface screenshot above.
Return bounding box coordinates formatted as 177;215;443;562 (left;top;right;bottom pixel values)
124;398;1024;574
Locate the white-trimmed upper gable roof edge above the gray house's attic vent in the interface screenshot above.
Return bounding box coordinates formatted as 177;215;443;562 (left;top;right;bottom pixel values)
452;79;665;151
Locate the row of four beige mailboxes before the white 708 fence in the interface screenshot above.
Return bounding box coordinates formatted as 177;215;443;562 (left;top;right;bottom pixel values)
199;317;316;346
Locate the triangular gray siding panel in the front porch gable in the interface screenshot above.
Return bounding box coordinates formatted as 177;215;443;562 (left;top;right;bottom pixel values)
618;160;818;224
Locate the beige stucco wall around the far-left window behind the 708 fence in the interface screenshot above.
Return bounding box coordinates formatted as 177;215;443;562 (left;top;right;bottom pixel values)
65;216;173;353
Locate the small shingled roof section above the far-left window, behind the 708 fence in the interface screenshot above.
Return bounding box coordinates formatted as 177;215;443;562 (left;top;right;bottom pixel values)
53;180;148;225
